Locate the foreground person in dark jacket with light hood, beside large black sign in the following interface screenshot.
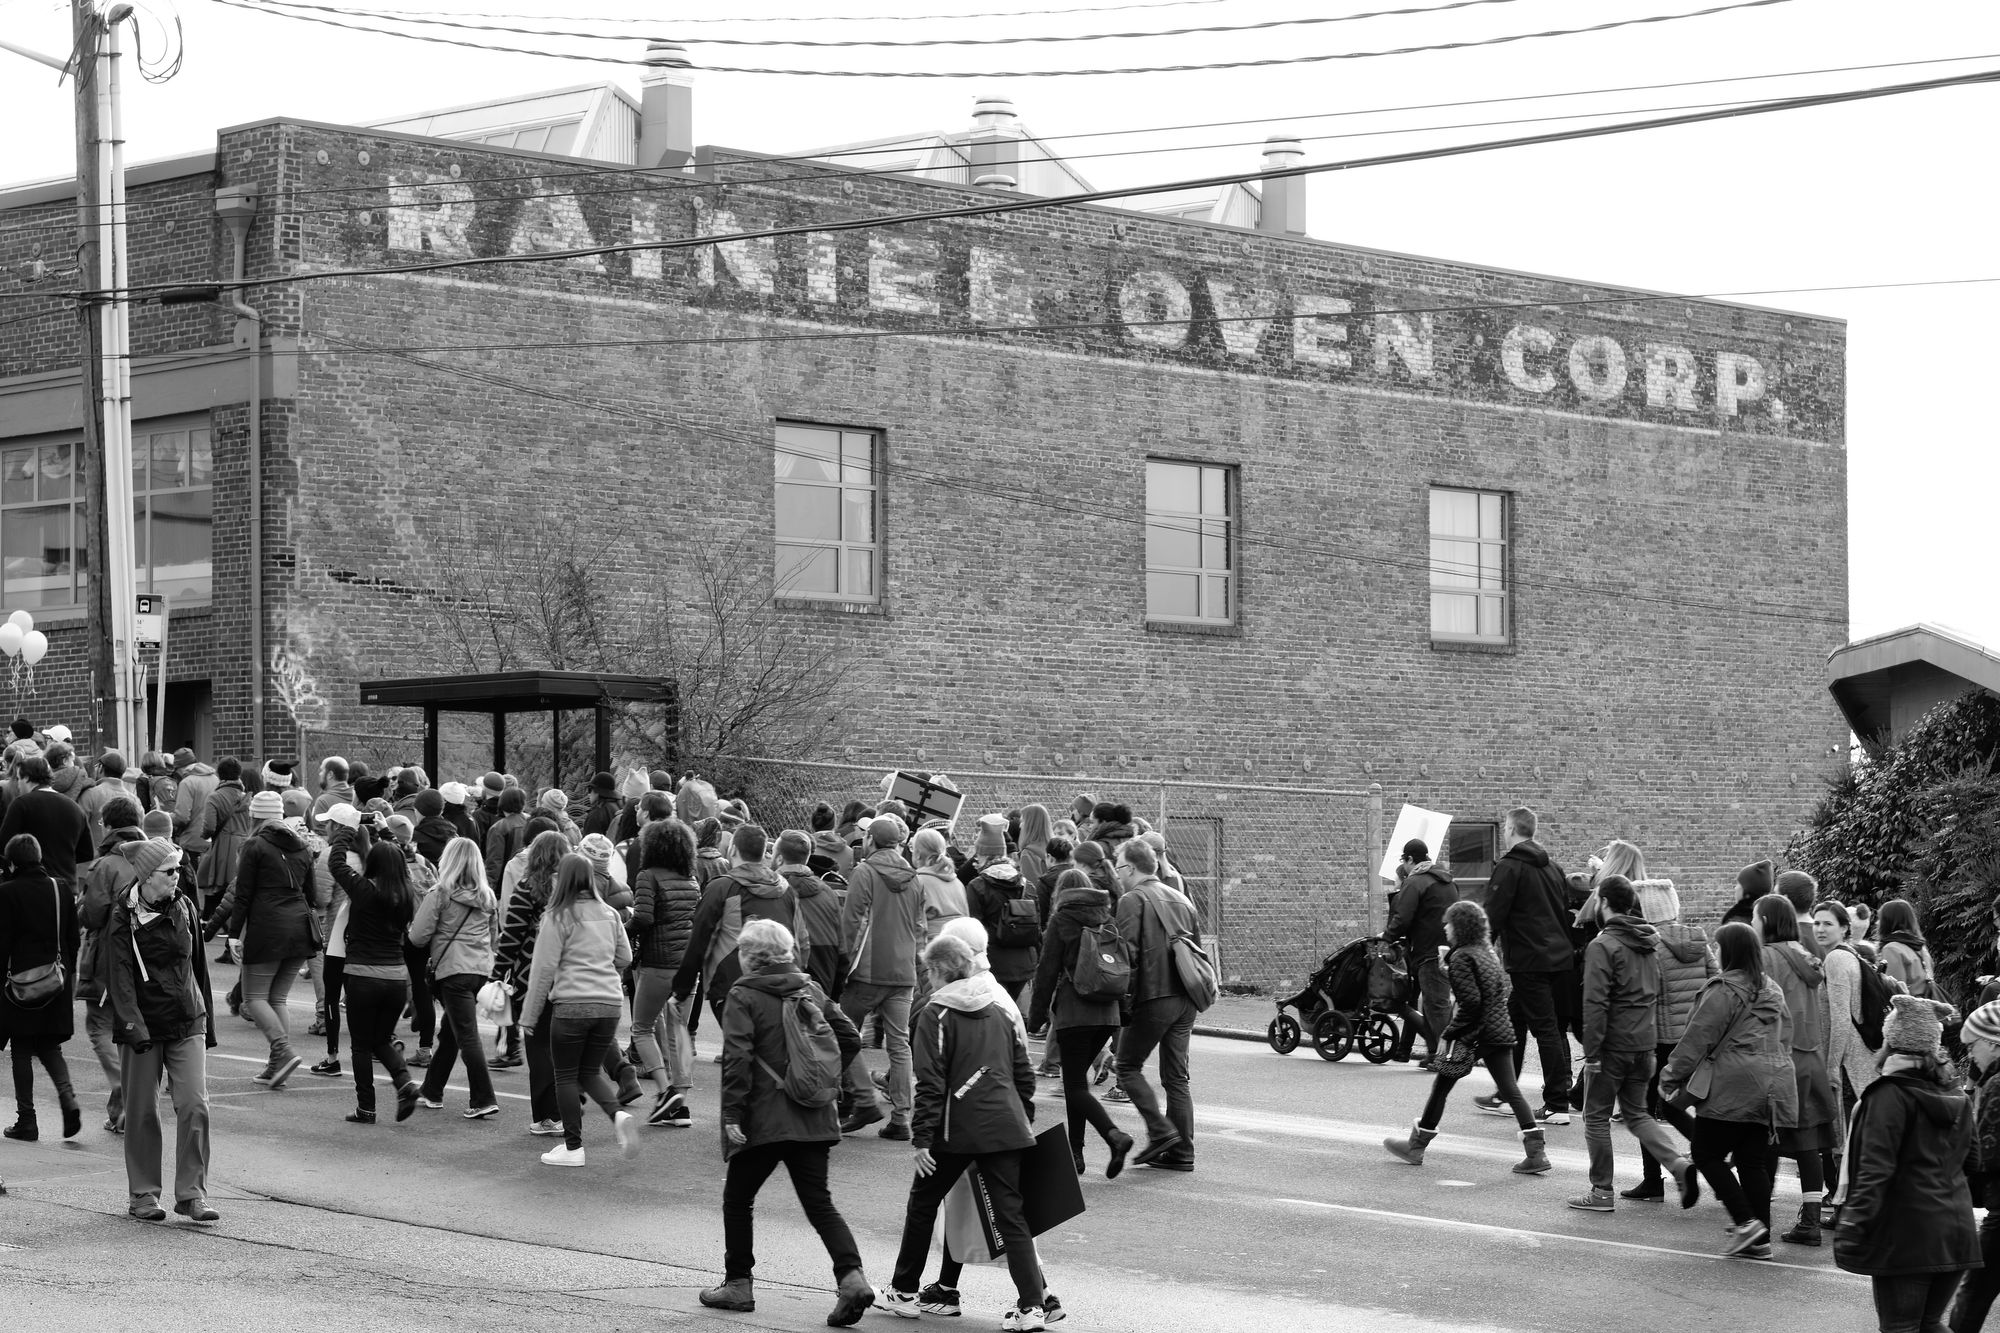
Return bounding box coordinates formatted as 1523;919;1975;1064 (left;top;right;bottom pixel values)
882;935;1046;1329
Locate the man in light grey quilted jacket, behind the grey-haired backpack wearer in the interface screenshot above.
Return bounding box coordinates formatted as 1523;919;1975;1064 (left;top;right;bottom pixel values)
840;815;926;1139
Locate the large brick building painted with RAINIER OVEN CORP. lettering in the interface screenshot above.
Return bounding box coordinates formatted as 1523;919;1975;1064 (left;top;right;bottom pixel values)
0;80;1846;979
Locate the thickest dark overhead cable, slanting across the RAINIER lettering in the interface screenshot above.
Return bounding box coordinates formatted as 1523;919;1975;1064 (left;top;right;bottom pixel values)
72;70;2000;296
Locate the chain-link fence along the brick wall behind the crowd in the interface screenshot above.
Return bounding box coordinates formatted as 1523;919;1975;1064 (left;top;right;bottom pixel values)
704;759;1384;989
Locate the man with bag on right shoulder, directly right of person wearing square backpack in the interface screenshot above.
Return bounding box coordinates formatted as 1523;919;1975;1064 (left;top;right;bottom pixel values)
1116;839;1200;1171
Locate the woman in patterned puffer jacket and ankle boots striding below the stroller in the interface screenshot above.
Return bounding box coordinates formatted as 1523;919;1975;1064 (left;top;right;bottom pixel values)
1382;899;1552;1175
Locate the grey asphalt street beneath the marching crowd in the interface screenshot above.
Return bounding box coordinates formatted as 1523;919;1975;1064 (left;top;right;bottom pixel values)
0;969;1874;1333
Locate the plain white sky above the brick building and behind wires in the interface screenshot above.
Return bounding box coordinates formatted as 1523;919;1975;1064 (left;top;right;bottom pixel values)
0;0;2000;646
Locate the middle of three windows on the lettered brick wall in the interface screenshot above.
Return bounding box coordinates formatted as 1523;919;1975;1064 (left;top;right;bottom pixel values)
1146;458;1236;624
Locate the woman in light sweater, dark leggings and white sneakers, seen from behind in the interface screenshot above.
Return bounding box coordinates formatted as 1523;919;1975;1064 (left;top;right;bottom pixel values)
520;852;638;1167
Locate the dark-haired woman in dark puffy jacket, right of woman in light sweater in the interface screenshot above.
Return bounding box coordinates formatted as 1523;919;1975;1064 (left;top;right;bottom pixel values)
630;819;702;1129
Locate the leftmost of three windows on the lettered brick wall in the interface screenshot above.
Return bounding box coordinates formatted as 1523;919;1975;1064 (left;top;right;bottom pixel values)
772;422;882;602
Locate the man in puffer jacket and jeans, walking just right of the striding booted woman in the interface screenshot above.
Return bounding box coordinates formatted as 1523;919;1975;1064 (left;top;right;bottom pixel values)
1570;875;1700;1213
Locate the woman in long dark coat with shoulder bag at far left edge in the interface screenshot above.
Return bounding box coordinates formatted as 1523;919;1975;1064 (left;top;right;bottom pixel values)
0;833;84;1143
